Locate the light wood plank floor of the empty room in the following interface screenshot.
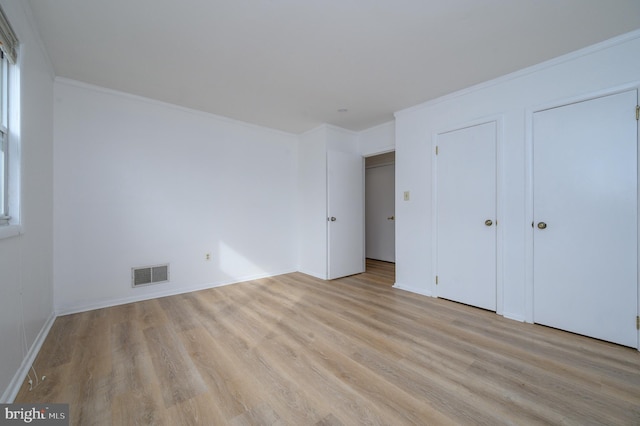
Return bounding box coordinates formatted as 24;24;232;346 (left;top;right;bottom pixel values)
16;262;640;426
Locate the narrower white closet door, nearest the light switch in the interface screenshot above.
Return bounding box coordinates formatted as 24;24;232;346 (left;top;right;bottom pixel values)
436;122;497;311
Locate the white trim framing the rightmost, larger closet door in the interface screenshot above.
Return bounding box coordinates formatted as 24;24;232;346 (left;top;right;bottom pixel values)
524;81;640;351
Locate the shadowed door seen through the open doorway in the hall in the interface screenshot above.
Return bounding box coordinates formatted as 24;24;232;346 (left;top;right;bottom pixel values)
365;164;396;262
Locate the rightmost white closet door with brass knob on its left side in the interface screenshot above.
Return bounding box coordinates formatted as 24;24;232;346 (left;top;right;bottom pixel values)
533;90;638;347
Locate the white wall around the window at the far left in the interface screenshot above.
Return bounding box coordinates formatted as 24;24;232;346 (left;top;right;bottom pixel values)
0;0;53;402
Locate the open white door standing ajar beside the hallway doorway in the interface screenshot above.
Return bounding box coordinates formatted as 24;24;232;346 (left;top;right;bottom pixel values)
327;151;365;279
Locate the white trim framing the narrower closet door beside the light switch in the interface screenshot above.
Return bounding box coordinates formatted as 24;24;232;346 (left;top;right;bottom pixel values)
426;114;505;315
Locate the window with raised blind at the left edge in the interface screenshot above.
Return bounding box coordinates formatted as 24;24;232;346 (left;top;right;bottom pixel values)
0;4;18;230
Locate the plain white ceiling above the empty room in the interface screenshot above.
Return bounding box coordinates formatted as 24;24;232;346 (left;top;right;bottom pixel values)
29;0;640;133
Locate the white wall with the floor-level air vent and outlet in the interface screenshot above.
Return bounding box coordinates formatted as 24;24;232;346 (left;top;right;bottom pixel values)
54;79;298;312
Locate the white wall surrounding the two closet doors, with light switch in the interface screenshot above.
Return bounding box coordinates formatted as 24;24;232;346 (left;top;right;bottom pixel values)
396;32;640;321
